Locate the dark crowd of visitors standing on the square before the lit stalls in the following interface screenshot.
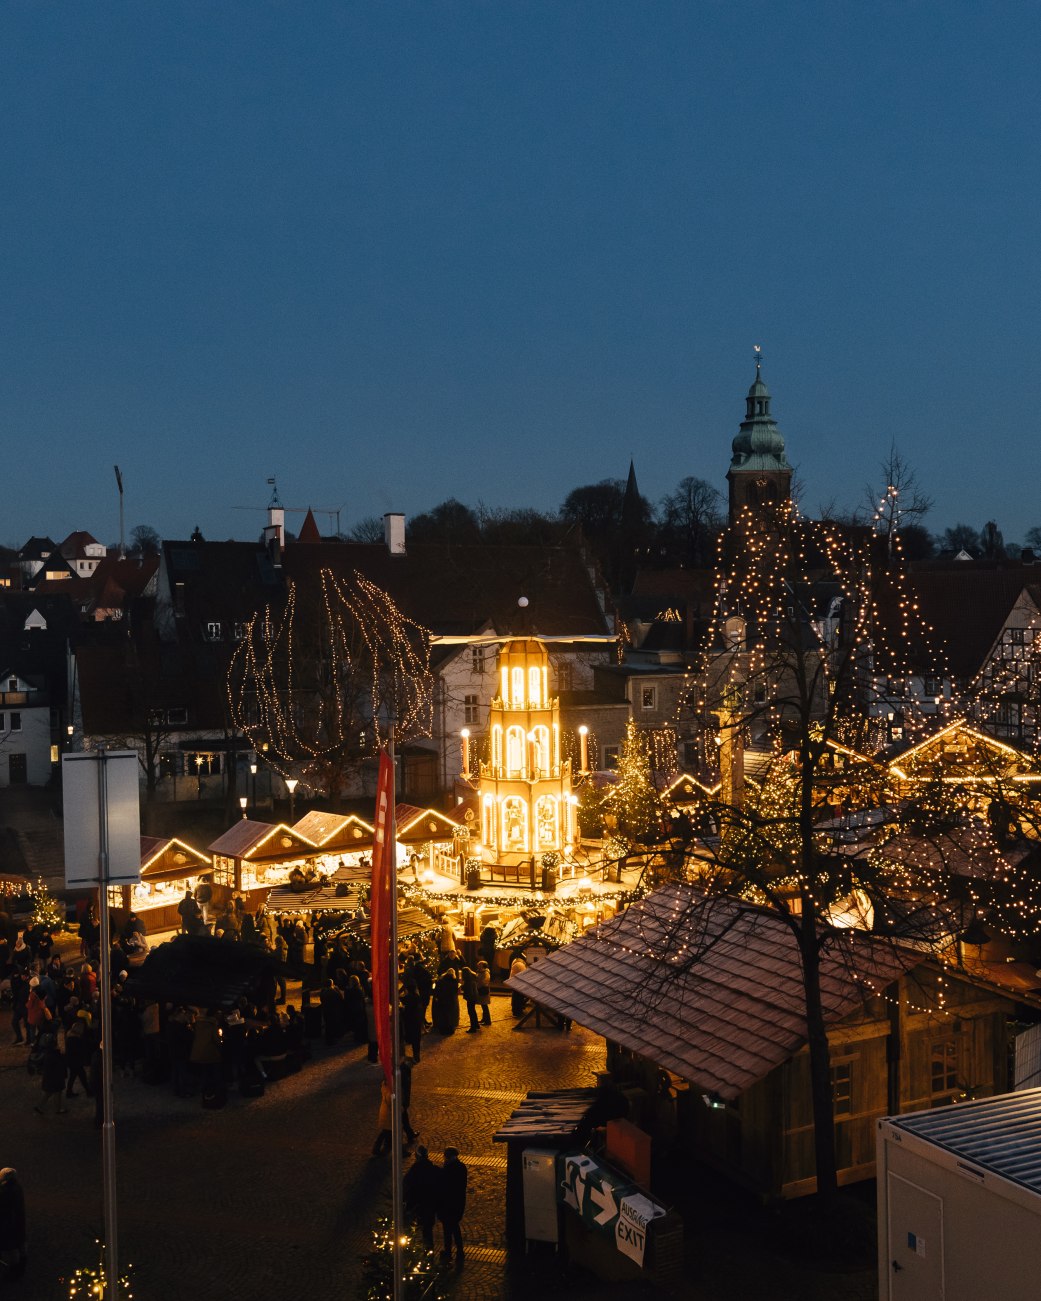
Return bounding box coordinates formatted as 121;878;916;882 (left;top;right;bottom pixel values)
0;891;533;1266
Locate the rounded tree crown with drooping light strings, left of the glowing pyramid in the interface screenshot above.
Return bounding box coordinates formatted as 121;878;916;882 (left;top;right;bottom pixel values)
228;569;433;801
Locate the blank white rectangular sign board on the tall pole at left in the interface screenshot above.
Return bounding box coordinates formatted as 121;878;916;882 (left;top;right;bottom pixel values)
61;749;141;890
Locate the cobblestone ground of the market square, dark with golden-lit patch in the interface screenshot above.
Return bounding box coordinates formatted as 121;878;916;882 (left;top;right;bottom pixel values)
0;997;874;1301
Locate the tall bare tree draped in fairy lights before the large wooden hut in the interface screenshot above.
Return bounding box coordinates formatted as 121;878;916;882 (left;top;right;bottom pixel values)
666;491;1041;1197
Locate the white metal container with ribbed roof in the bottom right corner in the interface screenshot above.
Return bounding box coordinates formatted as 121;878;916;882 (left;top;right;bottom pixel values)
877;1089;1041;1301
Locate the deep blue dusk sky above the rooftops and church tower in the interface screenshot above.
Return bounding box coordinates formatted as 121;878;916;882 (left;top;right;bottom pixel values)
0;0;1041;545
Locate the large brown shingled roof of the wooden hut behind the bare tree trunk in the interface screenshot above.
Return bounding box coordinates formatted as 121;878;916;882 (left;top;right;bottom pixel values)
509;885;921;1102
